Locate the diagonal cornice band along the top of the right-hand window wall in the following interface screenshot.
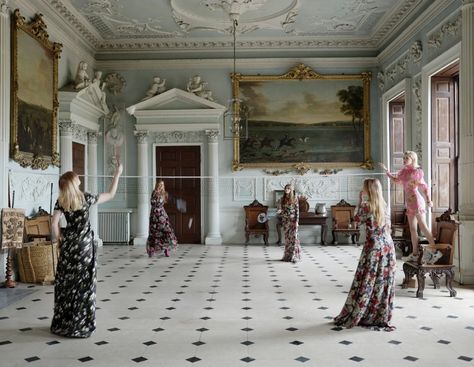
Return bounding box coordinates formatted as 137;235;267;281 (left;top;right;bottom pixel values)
377;0;452;65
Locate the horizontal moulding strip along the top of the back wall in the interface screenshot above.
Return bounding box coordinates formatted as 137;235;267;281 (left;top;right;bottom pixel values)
96;57;379;70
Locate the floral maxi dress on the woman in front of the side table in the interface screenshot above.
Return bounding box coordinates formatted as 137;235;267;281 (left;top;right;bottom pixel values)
281;200;301;263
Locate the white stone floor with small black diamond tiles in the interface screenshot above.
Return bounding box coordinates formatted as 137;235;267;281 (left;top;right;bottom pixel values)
0;245;474;367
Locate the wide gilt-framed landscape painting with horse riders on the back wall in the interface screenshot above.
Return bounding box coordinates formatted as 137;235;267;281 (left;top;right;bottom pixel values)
231;64;373;173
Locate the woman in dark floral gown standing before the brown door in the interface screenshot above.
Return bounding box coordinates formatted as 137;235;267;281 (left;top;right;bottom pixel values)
147;180;178;257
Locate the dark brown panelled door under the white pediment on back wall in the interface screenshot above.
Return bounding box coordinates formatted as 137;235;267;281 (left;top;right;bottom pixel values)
155;146;201;243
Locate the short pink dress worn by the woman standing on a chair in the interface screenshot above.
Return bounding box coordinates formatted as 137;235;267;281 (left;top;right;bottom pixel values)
387;165;430;217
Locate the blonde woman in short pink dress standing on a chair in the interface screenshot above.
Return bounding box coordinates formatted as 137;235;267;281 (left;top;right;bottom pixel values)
379;151;434;261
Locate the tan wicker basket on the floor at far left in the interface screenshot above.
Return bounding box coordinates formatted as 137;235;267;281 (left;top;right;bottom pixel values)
18;241;58;283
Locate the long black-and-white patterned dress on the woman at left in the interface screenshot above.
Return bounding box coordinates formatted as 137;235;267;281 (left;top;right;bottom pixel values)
51;193;98;338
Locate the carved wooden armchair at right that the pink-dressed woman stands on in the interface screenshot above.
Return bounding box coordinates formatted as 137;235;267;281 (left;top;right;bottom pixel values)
402;209;459;298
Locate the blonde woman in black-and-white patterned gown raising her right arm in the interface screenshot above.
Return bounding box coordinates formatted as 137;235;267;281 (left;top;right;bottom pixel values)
51;164;123;338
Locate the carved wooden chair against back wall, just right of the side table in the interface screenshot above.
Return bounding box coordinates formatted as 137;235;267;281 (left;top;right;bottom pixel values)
331;199;360;245
